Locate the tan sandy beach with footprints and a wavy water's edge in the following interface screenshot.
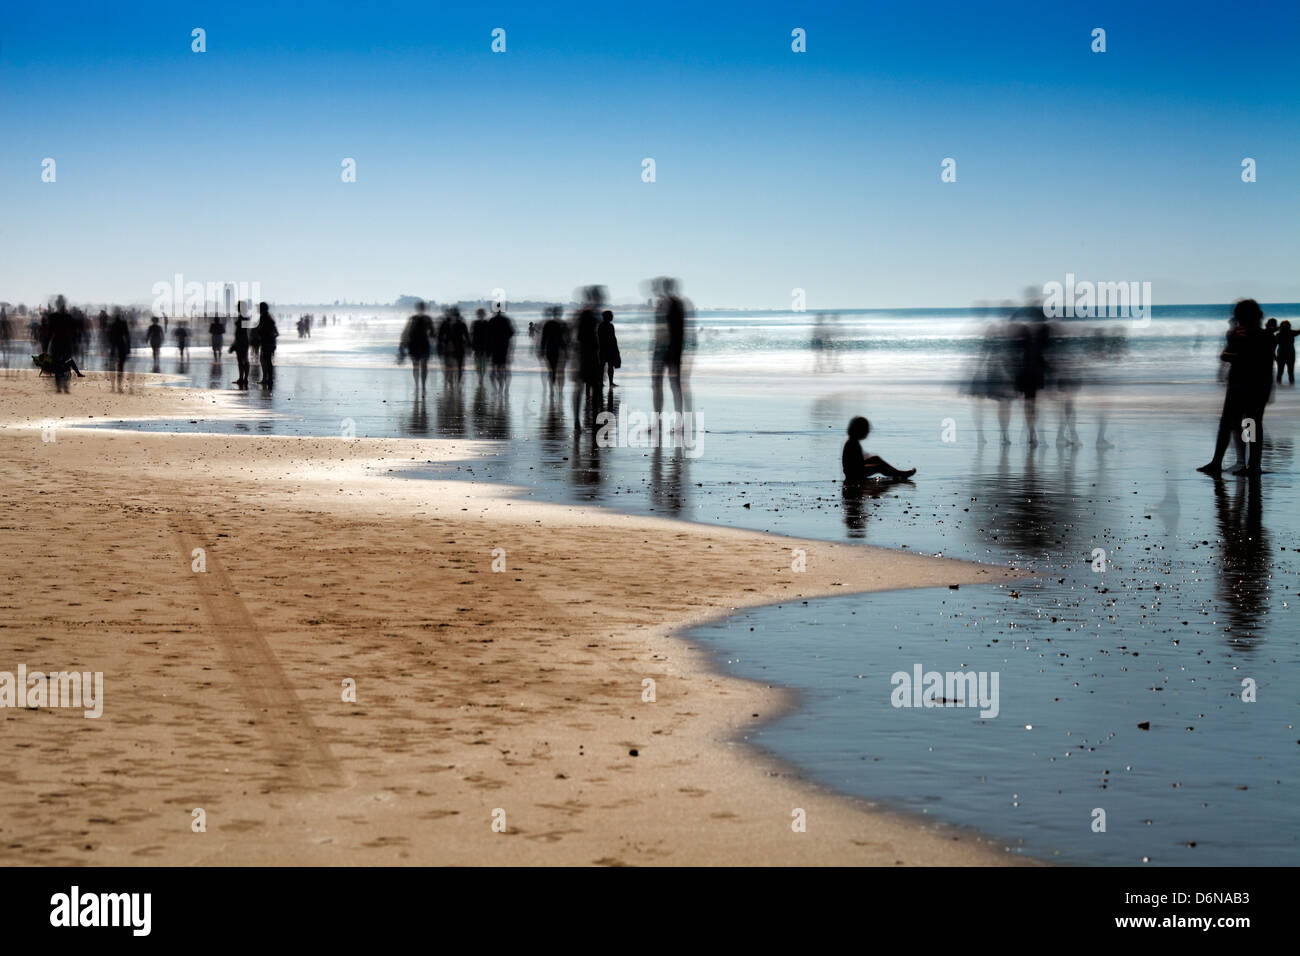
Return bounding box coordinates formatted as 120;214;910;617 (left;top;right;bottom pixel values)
0;373;1015;865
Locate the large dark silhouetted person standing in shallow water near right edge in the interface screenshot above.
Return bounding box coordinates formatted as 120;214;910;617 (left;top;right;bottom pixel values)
1197;299;1273;477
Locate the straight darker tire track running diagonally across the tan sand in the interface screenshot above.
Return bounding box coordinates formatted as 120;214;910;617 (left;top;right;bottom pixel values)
172;511;347;790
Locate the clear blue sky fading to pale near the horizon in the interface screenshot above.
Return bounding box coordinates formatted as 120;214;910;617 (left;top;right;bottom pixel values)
0;1;1300;308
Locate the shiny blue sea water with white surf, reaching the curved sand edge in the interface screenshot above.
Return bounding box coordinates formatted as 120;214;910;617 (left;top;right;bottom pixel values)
73;306;1300;865
